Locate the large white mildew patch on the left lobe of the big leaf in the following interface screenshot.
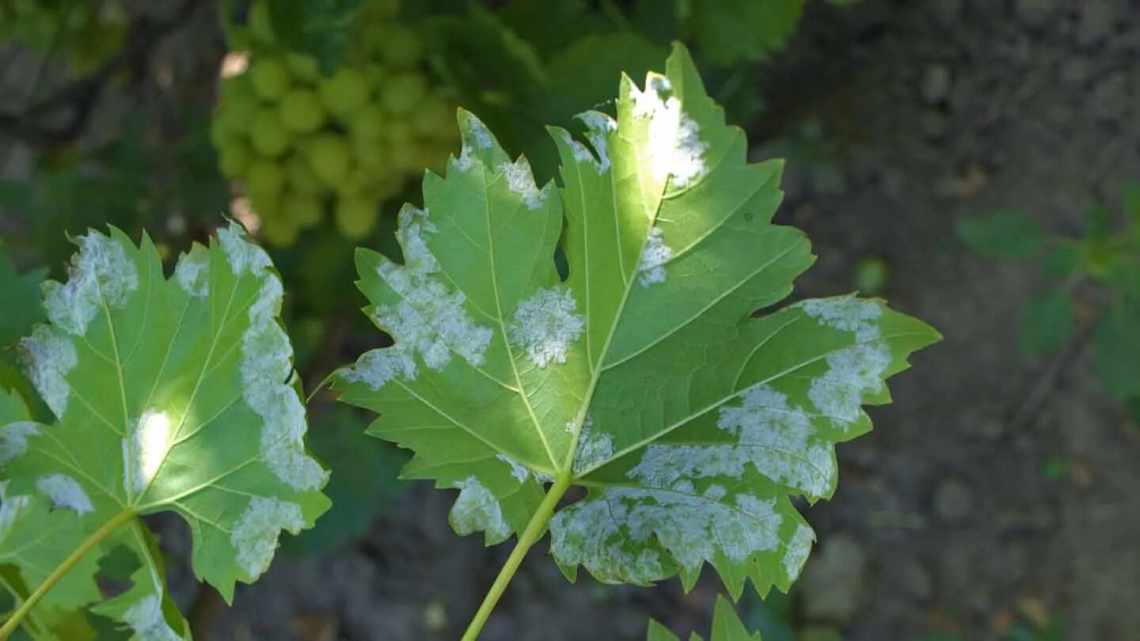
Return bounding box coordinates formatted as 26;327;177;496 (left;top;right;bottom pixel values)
364;205;492;376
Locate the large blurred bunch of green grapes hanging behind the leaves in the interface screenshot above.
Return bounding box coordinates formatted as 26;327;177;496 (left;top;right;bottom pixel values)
212;0;457;245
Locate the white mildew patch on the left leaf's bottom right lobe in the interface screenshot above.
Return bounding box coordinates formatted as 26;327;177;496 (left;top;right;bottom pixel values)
229;496;304;579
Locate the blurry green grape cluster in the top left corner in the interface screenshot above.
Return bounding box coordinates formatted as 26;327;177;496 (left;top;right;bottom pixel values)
0;0;128;71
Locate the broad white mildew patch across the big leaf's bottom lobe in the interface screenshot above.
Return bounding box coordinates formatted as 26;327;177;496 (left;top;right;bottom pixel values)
551;482;782;584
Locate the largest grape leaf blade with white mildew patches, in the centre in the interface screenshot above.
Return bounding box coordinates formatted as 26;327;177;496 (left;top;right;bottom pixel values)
335;47;938;594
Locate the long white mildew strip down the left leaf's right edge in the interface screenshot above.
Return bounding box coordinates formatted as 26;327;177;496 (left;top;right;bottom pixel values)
233;232;328;490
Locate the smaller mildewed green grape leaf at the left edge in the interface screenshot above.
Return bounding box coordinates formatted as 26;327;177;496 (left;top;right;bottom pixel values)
0;225;328;640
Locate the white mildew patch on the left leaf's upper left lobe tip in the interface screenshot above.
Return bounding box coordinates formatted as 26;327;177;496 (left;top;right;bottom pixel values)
43;232;139;336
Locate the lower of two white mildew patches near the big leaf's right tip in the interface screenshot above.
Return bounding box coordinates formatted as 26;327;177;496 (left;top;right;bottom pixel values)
807;342;890;423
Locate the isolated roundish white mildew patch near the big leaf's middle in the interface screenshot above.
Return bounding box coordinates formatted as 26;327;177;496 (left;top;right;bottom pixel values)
507;286;586;367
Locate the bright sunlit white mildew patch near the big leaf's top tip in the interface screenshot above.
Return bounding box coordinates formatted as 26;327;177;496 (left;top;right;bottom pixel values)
632;73;708;187
